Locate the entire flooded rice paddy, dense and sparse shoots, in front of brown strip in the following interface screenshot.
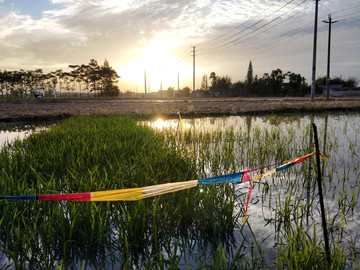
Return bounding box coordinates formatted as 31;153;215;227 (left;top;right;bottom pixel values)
0;113;360;269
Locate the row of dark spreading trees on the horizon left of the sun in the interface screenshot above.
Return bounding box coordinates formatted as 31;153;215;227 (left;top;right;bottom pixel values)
0;59;120;97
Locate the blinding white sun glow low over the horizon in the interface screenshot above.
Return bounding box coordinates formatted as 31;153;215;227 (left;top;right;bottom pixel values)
116;43;192;92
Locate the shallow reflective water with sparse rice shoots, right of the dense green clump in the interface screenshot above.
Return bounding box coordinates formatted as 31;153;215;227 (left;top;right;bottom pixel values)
147;114;360;269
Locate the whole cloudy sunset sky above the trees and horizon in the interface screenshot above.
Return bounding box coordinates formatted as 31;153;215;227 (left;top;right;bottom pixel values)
0;0;360;92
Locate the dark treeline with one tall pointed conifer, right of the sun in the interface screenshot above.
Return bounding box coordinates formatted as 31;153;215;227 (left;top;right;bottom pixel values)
200;61;358;97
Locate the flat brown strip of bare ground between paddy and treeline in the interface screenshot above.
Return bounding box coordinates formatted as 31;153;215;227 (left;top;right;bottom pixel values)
0;97;360;122
